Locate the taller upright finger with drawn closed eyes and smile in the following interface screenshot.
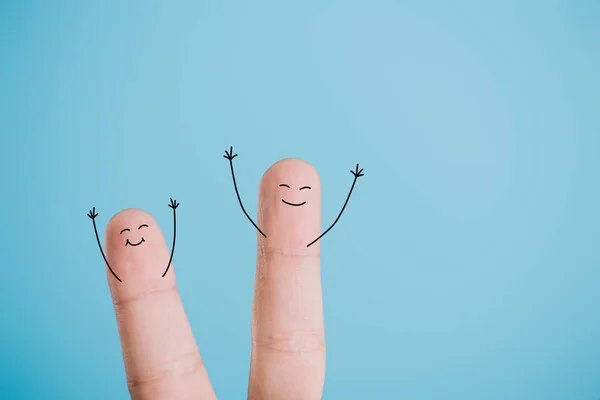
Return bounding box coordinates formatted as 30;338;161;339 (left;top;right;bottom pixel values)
249;159;325;400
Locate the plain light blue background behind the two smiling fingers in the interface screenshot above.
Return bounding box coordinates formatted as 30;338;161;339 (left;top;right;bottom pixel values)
0;0;600;400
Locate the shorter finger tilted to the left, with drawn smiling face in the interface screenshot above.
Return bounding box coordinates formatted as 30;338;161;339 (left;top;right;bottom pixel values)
106;209;216;400
